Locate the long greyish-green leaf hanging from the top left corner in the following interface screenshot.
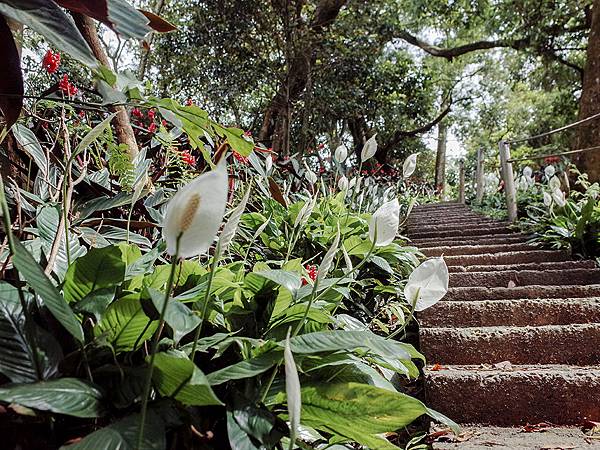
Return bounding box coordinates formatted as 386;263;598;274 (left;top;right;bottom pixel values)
0;0;98;68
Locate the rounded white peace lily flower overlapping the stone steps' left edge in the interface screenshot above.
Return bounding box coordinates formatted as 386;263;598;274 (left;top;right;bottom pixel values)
404;257;449;311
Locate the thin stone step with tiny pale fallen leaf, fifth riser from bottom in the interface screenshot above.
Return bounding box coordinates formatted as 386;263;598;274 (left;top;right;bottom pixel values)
449;269;600;287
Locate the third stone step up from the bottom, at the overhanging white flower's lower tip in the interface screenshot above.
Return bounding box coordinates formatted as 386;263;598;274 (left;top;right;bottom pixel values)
418;297;600;328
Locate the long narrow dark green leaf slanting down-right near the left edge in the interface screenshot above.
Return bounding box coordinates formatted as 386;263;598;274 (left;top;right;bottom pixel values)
13;238;84;342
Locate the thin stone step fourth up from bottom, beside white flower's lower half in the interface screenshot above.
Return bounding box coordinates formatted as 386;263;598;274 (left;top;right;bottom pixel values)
442;284;600;301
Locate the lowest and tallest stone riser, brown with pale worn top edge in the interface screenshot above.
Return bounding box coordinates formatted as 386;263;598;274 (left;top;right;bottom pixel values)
425;365;600;426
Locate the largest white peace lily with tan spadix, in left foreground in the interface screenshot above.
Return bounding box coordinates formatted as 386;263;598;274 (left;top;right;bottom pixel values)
163;159;227;258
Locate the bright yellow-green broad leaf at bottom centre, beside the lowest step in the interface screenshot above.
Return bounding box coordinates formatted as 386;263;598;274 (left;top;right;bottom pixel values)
302;383;427;449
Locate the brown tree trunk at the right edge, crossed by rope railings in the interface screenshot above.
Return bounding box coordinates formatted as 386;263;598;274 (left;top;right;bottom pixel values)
573;0;600;181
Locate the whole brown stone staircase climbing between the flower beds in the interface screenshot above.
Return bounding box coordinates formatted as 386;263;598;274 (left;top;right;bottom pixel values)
407;203;600;450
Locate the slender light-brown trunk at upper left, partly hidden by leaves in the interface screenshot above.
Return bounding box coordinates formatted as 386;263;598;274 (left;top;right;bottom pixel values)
72;13;139;160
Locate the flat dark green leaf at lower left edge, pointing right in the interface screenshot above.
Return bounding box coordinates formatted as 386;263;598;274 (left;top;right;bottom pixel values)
0;378;104;418
